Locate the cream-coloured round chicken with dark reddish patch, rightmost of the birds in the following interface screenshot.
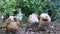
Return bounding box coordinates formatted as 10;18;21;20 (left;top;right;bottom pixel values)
40;13;51;29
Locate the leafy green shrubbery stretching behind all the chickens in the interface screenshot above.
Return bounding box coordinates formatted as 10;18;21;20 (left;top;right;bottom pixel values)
0;0;57;19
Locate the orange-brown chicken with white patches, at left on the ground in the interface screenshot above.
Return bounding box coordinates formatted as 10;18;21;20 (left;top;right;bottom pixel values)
2;16;20;32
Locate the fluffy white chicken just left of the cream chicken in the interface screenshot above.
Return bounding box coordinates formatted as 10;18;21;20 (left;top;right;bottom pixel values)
28;13;39;26
